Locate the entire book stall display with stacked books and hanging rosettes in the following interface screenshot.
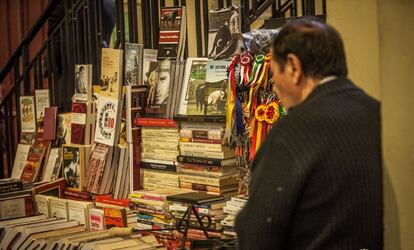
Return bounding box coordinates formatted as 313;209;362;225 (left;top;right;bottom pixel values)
4;4;283;249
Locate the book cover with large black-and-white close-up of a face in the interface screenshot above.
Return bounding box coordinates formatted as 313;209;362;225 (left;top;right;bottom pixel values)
145;60;171;118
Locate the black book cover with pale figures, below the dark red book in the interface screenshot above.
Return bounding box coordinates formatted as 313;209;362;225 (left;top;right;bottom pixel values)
62;145;84;191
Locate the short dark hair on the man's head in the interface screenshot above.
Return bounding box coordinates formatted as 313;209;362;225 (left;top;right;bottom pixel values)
273;17;348;79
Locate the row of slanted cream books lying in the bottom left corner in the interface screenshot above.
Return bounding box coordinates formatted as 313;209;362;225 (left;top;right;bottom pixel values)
0;214;160;249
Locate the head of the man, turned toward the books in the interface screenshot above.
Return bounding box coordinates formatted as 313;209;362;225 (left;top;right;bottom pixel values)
271;18;348;109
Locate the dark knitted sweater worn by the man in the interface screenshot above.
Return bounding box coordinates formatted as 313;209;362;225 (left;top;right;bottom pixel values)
236;78;383;250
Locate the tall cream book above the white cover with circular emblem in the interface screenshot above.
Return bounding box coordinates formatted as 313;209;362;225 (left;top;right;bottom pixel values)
101;48;123;100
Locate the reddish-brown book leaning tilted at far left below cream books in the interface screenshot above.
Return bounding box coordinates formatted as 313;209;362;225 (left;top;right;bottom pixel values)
21;140;50;182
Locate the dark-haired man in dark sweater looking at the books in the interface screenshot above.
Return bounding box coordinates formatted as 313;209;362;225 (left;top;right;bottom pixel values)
236;19;383;250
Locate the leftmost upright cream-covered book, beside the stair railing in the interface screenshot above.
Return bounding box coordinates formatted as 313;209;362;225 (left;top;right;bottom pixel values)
20;96;37;133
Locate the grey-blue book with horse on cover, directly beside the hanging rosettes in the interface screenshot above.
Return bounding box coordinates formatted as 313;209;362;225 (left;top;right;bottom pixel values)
200;60;230;116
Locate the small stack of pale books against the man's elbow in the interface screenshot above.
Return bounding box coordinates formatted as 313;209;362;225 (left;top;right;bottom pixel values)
221;196;247;238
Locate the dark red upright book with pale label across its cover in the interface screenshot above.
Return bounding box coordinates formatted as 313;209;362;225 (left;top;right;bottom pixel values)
70;102;87;144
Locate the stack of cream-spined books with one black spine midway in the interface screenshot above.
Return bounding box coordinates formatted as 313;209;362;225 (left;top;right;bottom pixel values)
141;121;179;189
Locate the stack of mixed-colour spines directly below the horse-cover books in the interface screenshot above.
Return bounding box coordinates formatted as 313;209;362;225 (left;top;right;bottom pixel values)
177;122;238;198
